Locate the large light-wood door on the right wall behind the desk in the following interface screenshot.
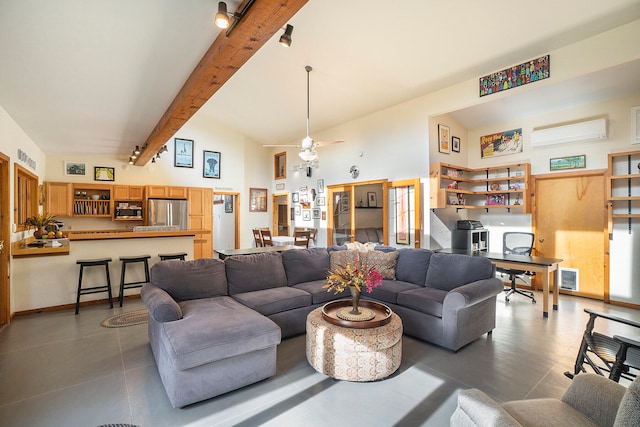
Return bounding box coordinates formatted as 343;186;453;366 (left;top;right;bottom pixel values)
533;170;609;300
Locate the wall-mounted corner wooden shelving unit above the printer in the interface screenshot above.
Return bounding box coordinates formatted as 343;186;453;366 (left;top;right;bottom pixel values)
430;162;531;213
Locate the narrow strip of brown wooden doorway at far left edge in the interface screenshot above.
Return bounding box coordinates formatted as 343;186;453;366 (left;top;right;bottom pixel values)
0;153;11;326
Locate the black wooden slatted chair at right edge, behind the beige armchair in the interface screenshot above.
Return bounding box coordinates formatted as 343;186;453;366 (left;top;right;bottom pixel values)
564;308;640;382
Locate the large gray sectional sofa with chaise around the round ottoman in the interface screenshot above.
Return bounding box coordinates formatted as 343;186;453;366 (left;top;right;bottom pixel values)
141;247;503;407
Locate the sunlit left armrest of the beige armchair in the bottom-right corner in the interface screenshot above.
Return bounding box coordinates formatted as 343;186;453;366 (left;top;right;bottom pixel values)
451;389;520;427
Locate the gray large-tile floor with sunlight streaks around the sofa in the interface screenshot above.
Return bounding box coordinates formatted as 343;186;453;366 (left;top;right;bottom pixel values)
0;295;640;427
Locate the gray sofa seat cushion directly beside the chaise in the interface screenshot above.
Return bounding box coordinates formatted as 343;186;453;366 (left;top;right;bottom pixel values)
233;286;311;316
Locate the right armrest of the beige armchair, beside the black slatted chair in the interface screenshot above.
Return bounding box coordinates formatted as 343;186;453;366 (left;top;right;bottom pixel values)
562;374;627;426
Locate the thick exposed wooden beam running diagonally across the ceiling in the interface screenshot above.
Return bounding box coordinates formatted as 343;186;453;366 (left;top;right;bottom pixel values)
135;0;308;166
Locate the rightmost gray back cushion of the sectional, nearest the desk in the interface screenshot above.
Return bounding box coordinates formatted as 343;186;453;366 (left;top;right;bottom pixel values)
426;252;494;291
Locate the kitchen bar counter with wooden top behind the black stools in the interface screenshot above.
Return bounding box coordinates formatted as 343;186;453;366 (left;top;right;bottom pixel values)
11;230;201;314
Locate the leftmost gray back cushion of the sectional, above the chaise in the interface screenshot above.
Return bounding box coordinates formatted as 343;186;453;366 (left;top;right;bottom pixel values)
151;258;227;301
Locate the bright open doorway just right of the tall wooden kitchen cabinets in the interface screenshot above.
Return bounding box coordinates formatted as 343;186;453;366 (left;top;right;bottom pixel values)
213;191;240;251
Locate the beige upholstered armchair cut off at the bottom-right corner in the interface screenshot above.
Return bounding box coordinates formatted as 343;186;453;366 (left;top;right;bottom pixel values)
451;374;640;426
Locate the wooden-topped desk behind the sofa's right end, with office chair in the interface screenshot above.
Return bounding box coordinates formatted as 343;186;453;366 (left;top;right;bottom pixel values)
435;249;562;317
